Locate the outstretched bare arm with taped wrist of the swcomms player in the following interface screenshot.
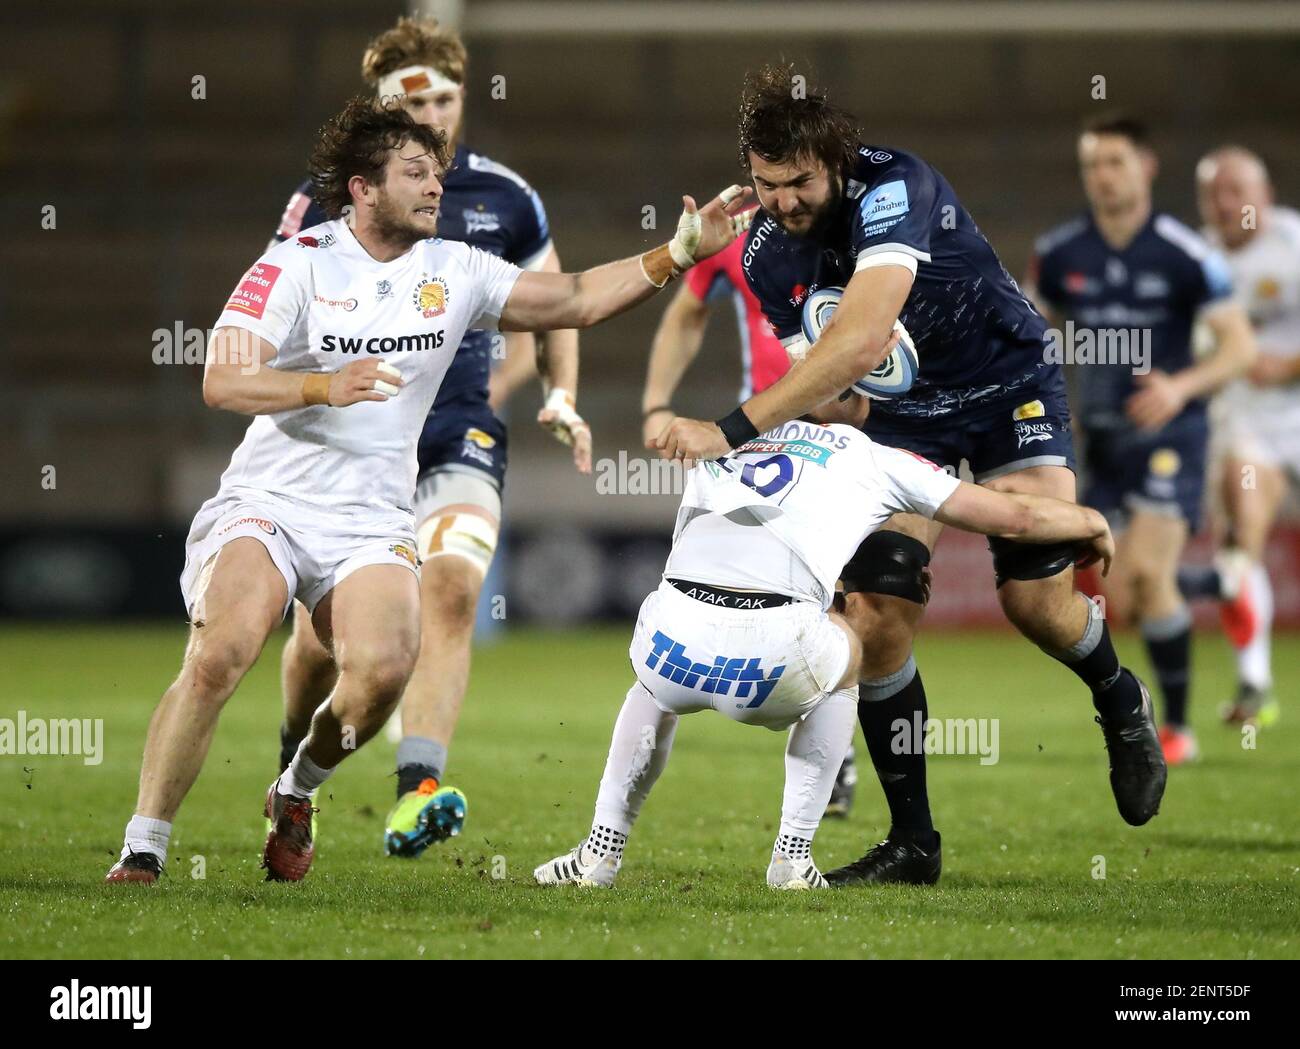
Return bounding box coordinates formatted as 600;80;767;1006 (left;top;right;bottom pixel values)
501;186;750;331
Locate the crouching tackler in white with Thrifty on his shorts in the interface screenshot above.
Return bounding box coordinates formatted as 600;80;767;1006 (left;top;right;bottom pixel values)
533;391;1114;889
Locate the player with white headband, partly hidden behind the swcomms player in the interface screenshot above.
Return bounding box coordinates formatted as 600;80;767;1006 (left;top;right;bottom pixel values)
276;18;592;857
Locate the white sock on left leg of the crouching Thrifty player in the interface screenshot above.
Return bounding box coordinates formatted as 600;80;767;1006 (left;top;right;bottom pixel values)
592;681;677;854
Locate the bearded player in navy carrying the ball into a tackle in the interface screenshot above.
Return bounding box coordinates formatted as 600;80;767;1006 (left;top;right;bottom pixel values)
654;66;1166;885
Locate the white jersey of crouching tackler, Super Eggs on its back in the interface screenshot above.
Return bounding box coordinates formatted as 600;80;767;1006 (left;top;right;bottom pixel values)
664;422;959;608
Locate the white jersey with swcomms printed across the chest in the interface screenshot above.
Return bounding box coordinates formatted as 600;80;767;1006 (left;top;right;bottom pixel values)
217;220;521;528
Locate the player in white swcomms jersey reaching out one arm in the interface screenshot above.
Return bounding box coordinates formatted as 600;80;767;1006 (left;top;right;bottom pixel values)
107;97;748;883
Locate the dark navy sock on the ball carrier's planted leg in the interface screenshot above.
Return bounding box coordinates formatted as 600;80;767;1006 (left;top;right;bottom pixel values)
858;656;937;850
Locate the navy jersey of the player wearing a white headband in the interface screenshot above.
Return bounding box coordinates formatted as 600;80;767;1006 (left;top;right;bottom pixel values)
276;146;551;411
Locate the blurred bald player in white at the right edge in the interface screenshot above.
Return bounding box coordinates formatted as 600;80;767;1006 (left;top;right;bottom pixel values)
1179;146;1300;724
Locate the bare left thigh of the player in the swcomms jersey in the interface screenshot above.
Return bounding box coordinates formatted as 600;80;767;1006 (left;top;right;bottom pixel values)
186;537;289;676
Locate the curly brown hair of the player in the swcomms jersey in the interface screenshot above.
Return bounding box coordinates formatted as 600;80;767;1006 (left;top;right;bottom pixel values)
308;95;451;218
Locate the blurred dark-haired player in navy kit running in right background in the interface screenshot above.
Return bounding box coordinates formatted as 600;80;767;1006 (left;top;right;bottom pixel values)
1030;116;1255;764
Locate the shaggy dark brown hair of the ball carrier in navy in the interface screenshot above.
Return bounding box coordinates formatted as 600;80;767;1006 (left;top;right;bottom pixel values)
738;64;862;174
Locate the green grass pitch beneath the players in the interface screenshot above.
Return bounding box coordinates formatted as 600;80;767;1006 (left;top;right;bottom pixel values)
0;627;1300;958
